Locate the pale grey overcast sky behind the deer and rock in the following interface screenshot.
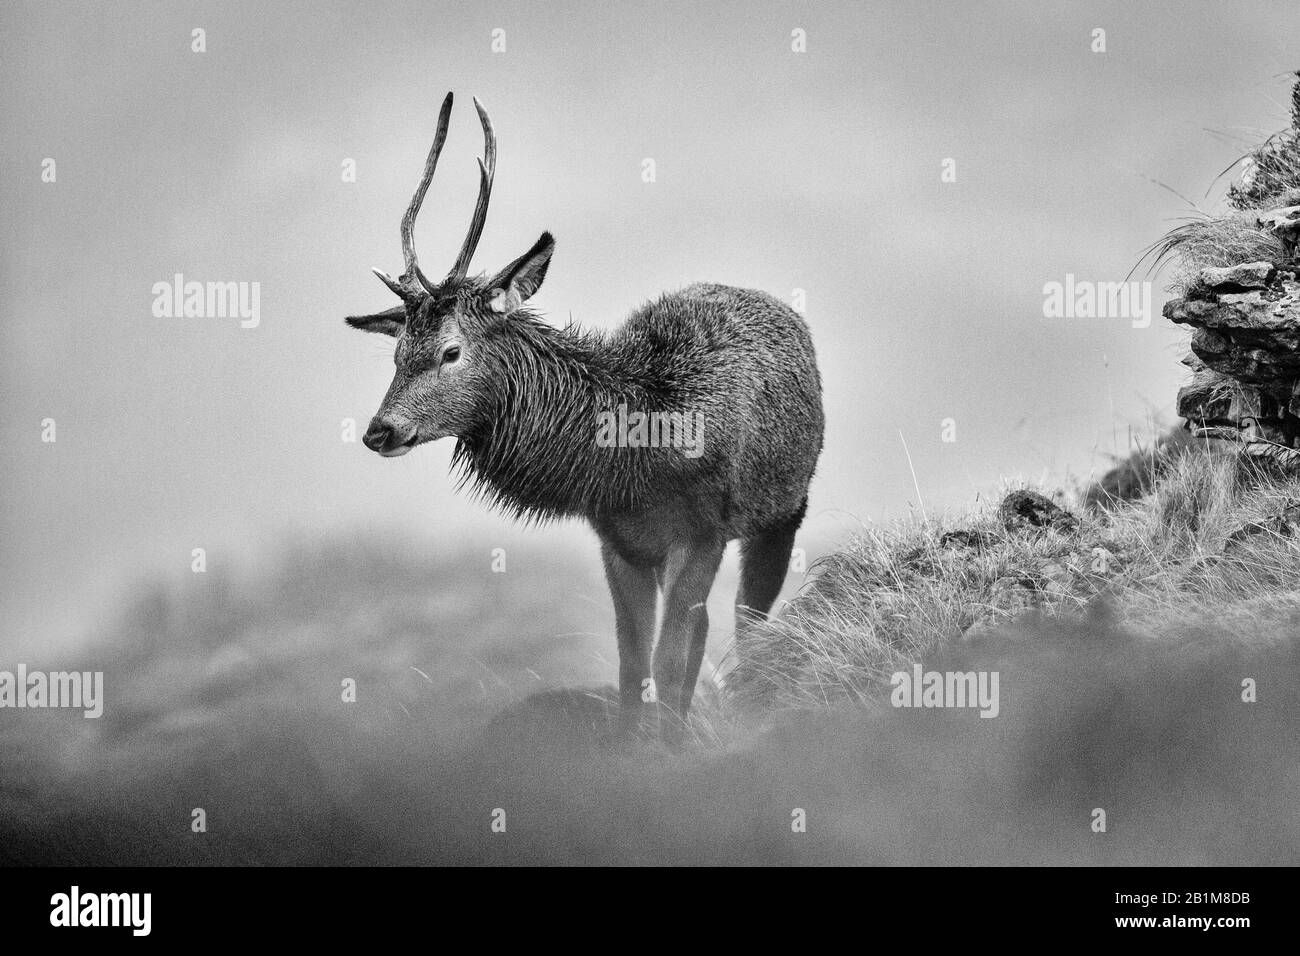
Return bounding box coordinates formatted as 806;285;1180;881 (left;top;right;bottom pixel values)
0;0;1300;655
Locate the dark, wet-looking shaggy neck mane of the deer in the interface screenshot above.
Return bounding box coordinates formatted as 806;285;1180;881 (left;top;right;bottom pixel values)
452;311;658;522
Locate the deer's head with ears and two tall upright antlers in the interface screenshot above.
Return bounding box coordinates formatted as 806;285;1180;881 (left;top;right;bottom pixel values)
347;92;555;457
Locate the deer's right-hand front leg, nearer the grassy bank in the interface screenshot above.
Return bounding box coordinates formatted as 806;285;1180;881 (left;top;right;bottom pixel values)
654;541;725;744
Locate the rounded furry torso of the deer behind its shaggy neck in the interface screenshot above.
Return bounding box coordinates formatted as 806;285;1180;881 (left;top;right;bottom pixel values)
598;284;823;548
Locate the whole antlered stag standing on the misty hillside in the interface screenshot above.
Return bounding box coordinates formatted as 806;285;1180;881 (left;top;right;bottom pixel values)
347;94;823;743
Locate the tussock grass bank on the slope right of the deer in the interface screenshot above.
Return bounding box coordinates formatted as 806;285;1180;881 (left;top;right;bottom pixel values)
727;451;1300;709
